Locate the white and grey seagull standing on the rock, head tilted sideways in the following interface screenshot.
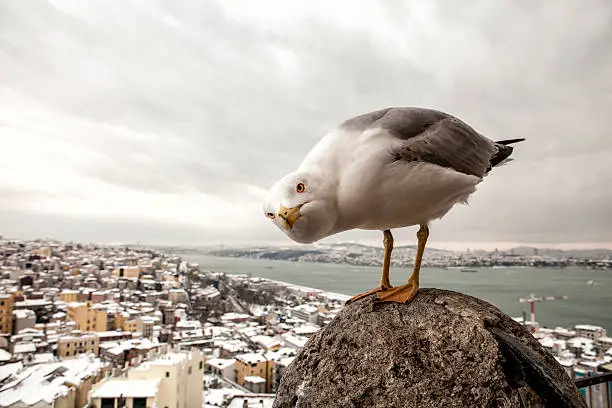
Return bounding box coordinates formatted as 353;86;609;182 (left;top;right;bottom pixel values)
263;107;525;304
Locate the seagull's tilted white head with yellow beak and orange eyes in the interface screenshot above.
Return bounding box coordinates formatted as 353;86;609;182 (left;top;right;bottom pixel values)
263;171;338;244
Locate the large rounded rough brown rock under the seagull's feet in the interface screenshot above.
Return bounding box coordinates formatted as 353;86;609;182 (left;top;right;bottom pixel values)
274;289;586;408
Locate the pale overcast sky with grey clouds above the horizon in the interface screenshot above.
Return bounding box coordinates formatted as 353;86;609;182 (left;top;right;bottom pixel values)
0;0;612;248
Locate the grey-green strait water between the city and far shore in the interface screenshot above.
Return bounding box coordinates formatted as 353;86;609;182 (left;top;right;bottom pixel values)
181;253;612;331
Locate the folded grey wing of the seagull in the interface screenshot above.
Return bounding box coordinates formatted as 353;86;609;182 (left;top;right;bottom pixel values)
341;108;502;177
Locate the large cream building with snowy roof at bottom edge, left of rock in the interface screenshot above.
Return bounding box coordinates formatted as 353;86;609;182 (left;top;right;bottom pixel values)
91;349;204;408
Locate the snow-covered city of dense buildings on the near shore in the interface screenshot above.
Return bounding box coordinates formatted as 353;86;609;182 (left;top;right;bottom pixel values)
0;239;612;408
